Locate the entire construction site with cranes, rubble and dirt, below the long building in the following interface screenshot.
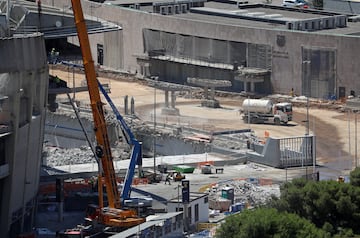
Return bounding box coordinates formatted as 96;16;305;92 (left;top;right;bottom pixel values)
0;0;360;238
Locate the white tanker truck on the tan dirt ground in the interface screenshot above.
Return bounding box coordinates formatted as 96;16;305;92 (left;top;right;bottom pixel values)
241;99;292;125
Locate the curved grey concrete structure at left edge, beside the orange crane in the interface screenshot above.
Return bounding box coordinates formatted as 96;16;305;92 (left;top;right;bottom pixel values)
0;34;48;237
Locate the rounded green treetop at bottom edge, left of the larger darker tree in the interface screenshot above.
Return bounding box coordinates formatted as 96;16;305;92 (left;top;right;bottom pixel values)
216;208;330;238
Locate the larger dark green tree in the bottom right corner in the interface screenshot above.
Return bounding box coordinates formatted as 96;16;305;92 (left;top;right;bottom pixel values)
272;179;360;237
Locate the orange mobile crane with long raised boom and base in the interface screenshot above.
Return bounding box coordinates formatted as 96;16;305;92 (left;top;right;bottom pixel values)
71;0;145;230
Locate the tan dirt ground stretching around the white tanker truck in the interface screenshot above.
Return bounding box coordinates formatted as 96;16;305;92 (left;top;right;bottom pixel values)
50;69;360;176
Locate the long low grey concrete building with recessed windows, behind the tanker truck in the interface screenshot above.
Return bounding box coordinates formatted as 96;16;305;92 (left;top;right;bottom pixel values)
43;0;360;98
